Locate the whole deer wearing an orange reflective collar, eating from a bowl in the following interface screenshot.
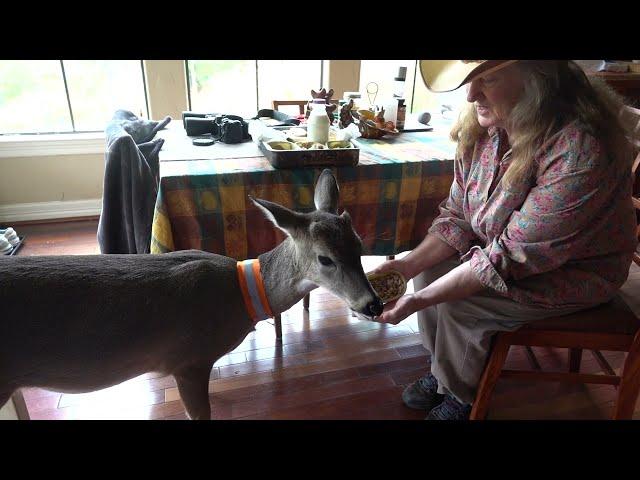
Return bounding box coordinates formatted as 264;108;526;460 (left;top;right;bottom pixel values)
0;169;383;420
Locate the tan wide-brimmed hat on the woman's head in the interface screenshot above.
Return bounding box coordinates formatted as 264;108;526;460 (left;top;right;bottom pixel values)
420;60;517;93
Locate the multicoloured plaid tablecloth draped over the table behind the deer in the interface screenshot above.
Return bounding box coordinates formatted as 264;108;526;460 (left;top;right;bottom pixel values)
151;132;455;260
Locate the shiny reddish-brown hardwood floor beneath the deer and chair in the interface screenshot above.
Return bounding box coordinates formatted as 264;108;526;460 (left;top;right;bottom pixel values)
5;220;640;420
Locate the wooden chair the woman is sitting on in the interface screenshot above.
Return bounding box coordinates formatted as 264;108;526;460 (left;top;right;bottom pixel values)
470;106;640;420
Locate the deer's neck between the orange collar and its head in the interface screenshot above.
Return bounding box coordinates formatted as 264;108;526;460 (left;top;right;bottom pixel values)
258;238;317;315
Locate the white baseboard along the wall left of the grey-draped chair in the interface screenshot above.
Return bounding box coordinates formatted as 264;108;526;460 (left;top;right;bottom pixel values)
0;198;102;224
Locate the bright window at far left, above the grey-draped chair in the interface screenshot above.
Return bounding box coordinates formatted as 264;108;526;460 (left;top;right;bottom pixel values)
0;60;148;134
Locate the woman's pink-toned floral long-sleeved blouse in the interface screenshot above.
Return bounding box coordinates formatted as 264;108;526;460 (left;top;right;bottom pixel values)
429;122;637;308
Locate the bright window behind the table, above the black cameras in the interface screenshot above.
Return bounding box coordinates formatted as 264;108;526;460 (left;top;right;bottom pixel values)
187;60;323;118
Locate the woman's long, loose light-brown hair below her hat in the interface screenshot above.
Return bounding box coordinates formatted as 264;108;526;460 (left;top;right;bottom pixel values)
451;60;632;191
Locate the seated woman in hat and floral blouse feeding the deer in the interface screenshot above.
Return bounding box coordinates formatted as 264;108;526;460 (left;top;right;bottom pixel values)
375;60;636;419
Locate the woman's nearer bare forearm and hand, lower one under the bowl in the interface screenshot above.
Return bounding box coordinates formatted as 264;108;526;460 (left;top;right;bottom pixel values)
375;262;485;325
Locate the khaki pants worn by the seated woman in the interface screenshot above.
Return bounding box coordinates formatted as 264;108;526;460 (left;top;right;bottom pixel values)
413;257;582;403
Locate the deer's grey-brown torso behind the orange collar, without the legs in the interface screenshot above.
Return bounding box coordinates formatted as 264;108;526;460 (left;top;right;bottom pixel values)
0;250;252;387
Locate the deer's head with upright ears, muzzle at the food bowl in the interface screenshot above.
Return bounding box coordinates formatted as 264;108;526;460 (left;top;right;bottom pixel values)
252;169;382;317
